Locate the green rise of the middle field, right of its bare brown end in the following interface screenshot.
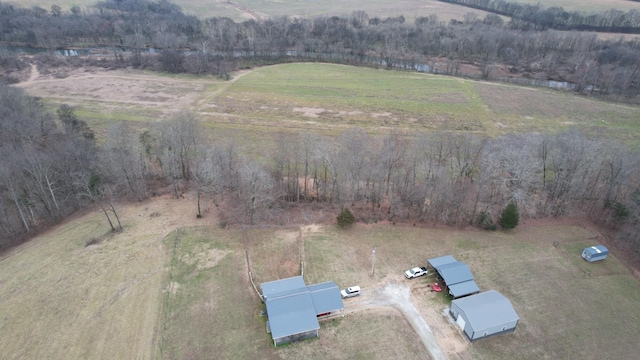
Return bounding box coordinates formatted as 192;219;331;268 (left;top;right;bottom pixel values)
214;64;640;145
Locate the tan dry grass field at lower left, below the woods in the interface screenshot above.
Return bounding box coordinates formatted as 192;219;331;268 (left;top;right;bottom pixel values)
0;198;206;359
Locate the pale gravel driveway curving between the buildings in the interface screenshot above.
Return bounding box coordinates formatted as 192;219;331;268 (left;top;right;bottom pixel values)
344;283;447;360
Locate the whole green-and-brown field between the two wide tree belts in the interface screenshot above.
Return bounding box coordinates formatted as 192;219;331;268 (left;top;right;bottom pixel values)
20;63;640;148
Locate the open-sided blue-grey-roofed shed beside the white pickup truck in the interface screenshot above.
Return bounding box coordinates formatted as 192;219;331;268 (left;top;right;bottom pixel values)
428;255;480;299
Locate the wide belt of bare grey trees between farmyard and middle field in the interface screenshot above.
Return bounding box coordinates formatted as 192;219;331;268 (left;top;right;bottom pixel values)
0;85;640;251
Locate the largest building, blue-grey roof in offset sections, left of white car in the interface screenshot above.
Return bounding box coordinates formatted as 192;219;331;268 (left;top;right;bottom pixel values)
260;276;344;346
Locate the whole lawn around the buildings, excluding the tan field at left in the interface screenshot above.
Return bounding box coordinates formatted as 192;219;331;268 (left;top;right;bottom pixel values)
162;224;640;359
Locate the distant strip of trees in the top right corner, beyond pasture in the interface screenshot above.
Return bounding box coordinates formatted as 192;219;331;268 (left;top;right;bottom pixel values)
439;0;640;34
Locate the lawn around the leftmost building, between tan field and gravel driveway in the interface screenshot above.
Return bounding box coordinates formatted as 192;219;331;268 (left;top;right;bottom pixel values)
159;228;428;359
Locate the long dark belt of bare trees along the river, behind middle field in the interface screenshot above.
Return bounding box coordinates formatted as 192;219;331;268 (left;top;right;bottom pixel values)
0;0;640;101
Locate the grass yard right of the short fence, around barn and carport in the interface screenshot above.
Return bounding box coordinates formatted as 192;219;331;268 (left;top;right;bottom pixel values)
305;224;640;359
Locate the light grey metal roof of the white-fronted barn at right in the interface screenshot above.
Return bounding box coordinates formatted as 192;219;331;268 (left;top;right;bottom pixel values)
451;290;520;332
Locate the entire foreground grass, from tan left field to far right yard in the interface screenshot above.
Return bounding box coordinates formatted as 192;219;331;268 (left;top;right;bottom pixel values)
0;198;640;359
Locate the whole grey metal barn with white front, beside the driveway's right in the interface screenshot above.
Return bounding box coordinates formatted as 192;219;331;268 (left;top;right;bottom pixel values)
449;290;520;342
